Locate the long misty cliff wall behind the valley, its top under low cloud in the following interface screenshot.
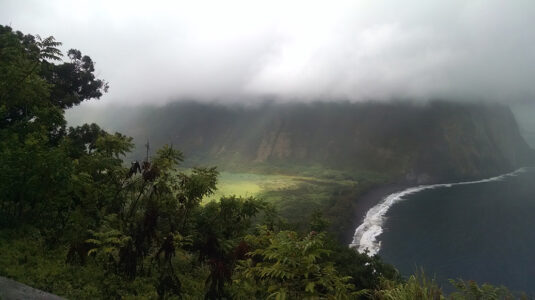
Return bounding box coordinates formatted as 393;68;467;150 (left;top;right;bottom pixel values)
90;102;533;183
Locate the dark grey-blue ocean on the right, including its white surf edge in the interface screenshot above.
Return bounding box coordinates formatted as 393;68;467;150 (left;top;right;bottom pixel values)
352;168;535;294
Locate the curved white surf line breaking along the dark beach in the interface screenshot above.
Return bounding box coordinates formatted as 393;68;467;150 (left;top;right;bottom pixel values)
349;168;526;256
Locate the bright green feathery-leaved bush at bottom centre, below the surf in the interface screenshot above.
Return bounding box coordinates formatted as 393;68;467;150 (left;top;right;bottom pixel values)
235;227;354;299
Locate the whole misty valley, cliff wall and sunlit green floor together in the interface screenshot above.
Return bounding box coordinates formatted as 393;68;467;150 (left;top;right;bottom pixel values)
67;101;535;243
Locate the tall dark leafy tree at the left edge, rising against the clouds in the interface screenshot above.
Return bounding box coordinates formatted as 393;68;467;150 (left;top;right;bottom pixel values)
0;26;109;230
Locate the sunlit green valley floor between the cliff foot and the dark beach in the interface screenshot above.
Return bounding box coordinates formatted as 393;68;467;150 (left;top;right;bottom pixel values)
198;165;390;241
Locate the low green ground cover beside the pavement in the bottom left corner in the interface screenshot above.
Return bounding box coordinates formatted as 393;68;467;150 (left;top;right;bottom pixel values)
0;227;156;299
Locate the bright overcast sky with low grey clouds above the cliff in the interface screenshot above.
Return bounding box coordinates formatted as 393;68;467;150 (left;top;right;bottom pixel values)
0;0;535;104
